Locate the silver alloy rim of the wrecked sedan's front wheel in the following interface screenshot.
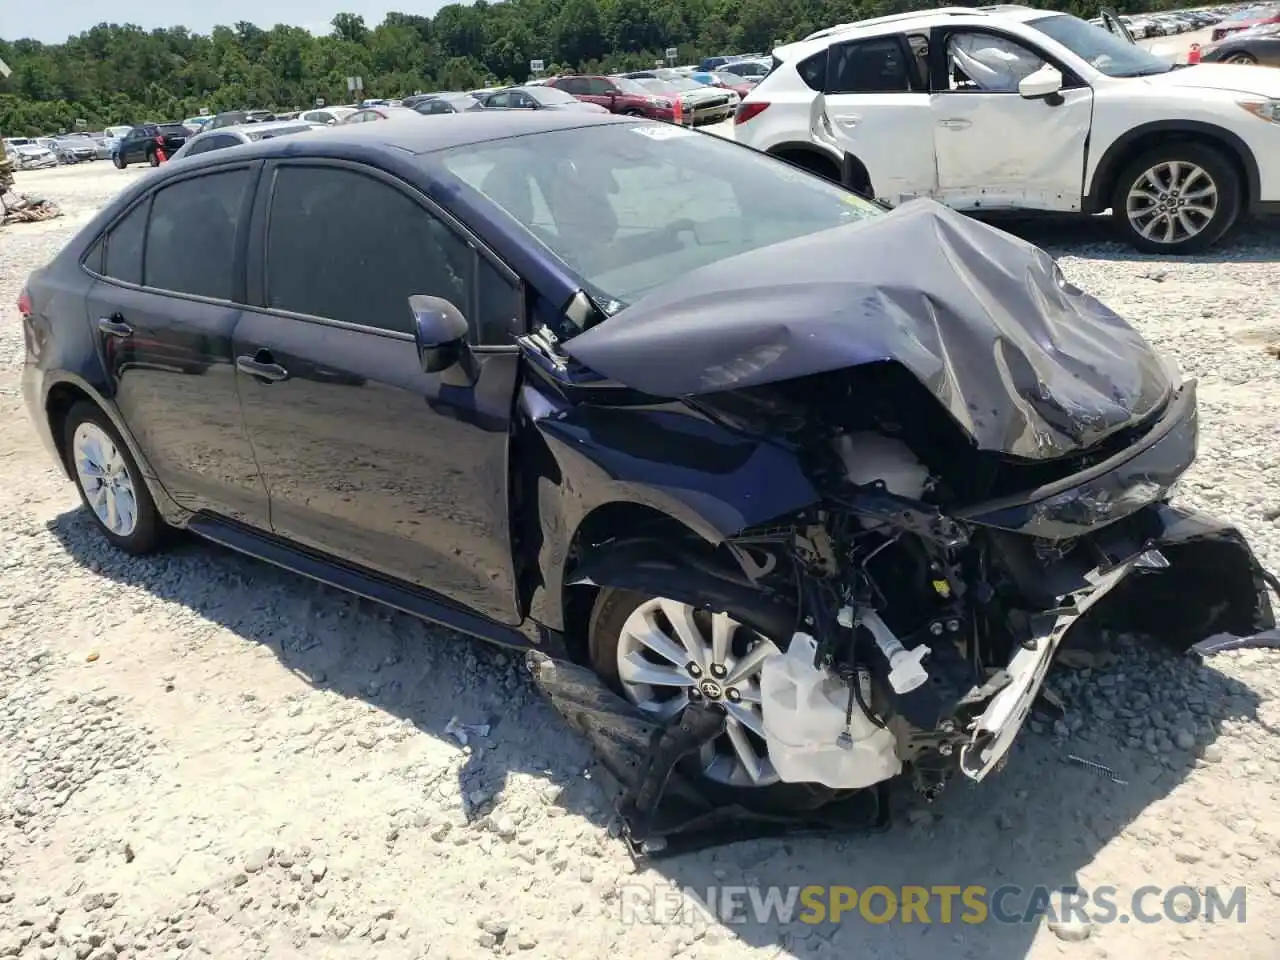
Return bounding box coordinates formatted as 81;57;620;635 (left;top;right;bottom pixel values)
617;599;781;787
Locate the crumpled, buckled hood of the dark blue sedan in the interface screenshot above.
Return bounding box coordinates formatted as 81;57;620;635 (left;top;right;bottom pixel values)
563;200;1171;460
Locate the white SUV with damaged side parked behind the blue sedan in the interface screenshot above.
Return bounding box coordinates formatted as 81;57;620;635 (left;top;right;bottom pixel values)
735;6;1280;253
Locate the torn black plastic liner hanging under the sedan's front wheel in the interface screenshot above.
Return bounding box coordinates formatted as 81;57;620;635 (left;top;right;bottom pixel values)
526;650;888;859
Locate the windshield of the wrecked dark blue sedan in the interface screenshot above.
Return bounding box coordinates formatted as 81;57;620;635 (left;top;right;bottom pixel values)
431;123;882;305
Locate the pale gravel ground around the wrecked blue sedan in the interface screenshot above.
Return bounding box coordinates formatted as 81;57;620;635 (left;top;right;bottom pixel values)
0;164;1280;960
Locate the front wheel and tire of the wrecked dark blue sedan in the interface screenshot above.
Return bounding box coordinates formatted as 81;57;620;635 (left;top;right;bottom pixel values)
588;583;835;813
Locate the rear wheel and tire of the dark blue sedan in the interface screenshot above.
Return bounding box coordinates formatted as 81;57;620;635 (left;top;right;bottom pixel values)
63;401;169;556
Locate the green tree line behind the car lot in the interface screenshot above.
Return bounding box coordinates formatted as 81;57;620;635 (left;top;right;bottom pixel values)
0;0;1208;136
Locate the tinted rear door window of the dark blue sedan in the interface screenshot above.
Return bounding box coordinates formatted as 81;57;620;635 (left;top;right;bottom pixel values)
143;169;250;300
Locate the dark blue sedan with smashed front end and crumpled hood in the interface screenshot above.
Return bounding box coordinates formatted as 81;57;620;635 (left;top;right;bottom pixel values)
19;111;1275;855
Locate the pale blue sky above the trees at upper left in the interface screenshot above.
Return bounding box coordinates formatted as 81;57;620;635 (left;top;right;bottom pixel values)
0;0;448;44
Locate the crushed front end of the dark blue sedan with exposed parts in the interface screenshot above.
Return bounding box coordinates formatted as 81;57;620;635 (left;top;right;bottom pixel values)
701;369;1275;795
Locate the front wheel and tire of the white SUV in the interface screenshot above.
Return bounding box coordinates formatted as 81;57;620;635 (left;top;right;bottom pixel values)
1111;143;1243;255
